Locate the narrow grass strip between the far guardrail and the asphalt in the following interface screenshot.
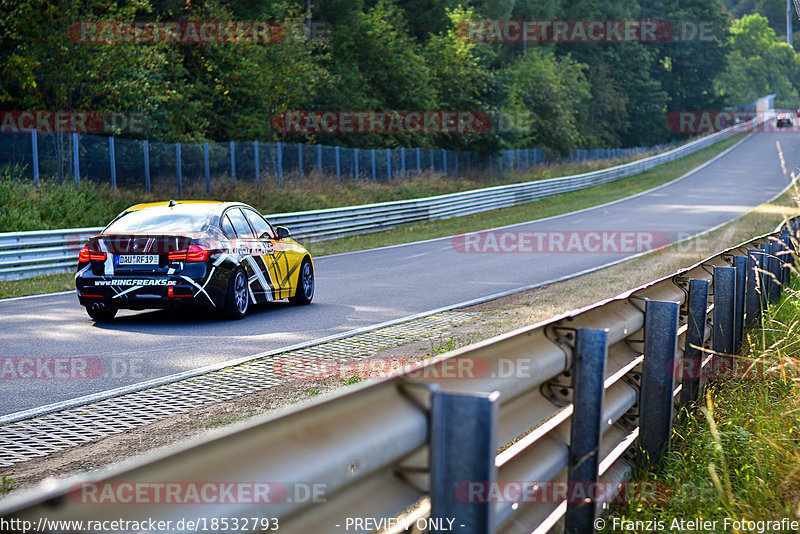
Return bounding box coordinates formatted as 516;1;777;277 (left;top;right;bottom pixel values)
0;134;746;298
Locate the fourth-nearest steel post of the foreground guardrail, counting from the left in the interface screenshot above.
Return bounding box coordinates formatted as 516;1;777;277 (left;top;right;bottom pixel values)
678;279;711;406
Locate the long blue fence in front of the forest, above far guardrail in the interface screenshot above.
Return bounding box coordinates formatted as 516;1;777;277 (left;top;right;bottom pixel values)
0;130;672;195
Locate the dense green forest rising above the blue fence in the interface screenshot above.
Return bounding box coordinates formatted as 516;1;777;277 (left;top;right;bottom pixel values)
0;0;800;153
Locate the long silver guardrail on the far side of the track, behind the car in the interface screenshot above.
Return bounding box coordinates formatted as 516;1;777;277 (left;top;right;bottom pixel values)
0;115;764;279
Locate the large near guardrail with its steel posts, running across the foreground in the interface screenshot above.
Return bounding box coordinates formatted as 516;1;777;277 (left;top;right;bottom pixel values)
0;219;800;534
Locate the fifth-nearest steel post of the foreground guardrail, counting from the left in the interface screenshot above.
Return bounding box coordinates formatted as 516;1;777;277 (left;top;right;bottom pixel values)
711;266;736;376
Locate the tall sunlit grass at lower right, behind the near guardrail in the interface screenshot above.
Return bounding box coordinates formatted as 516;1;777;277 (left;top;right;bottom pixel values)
605;280;800;532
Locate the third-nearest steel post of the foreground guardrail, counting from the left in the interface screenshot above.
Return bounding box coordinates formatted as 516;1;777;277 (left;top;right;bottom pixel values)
639;300;680;467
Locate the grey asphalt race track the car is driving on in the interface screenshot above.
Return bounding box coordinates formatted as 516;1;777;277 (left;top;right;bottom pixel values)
0;133;800;415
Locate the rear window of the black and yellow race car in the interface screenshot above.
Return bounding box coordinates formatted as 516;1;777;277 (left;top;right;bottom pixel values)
105;204;211;234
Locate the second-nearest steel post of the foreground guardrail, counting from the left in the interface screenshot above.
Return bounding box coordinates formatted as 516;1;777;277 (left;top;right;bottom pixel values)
565;328;608;534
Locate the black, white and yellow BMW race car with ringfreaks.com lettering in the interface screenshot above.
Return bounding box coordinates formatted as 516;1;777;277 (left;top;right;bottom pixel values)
75;200;314;321
